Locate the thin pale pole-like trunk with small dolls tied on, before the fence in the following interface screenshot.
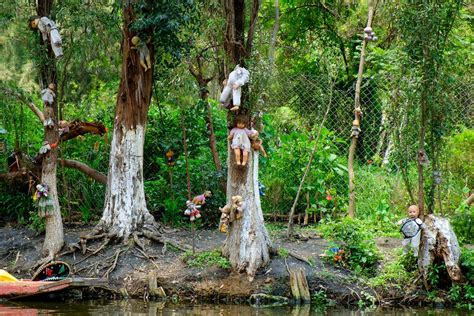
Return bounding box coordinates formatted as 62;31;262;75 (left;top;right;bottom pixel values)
348;0;374;217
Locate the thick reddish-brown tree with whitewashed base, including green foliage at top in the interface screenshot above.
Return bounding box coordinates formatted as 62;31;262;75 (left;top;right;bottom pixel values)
82;0;193;243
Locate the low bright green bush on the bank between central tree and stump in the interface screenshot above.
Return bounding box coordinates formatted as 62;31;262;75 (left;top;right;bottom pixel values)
320;217;380;273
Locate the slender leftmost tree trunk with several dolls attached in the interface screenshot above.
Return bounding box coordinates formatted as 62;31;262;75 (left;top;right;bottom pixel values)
37;0;64;259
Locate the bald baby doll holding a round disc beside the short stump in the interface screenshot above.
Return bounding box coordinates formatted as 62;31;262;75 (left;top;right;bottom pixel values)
397;205;424;257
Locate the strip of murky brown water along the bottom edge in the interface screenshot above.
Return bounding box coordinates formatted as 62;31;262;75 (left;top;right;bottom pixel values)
0;300;468;316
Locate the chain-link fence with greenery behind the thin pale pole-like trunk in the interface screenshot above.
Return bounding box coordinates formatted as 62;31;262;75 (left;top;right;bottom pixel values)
260;70;474;221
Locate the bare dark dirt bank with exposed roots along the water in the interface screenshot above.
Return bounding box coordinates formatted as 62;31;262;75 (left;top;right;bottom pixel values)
0;226;400;305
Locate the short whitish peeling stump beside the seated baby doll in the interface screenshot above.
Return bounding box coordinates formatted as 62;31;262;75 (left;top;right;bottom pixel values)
418;214;464;288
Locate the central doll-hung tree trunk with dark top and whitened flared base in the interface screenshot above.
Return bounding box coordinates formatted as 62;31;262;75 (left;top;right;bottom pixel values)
223;0;271;279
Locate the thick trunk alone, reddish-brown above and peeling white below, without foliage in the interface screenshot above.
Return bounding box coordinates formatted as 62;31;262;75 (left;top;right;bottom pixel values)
90;6;156;242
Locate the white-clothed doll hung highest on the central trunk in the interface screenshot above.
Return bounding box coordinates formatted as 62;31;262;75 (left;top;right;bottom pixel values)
219;65;250;111
